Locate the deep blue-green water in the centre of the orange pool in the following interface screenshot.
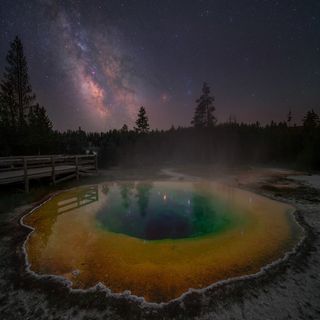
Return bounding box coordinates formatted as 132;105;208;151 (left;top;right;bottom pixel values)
97;183;239;240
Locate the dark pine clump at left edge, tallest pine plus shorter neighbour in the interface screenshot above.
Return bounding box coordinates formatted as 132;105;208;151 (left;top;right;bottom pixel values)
0;37;52;154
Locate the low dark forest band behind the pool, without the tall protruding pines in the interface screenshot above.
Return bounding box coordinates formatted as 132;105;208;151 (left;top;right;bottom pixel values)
0;119;320;170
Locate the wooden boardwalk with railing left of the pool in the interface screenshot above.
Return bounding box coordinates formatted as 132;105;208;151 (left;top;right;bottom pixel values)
0;155;98;192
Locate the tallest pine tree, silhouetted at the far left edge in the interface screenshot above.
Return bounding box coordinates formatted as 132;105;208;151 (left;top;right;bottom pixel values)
1;37;35;127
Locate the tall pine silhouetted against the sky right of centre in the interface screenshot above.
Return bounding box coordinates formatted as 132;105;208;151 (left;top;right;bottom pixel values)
191;82;217;128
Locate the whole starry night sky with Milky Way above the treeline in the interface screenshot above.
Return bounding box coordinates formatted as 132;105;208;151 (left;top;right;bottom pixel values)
0;0;320;131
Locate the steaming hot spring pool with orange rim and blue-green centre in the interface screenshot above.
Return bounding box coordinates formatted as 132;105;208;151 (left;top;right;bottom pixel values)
23;181;302;302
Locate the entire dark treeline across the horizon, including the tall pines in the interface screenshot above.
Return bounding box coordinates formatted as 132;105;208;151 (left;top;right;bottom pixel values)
0;37;320;170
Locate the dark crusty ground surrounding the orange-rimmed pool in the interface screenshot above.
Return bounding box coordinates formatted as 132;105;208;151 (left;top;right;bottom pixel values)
0;167;320;320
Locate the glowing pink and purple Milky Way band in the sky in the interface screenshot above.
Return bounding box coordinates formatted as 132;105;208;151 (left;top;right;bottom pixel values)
47;2;139;130
